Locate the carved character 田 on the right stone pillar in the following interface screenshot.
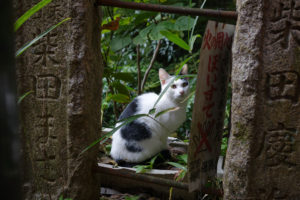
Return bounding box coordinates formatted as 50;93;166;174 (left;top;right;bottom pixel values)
266;71;300;103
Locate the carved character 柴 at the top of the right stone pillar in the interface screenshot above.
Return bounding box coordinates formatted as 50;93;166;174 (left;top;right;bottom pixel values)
271;0;300;48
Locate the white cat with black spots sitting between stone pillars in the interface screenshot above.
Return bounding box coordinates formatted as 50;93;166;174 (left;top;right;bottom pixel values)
111;65;189;164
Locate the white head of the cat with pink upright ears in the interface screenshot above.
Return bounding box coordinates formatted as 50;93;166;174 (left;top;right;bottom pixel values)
159;65;189;103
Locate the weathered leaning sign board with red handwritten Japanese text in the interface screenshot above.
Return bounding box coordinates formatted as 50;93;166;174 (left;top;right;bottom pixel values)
188;21;235;191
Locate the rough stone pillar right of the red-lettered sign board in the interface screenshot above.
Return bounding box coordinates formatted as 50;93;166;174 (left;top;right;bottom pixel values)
224;0;300;200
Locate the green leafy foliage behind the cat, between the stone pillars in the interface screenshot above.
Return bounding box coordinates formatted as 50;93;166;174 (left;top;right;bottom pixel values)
101;0;234;153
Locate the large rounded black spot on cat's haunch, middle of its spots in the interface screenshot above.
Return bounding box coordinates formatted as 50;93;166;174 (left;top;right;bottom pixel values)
121;121;151;141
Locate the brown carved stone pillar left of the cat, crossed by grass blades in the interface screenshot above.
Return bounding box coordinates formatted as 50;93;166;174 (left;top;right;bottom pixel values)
15;0;102;200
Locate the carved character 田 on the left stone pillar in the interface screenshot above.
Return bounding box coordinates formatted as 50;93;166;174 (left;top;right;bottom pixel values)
36;75;61;100
